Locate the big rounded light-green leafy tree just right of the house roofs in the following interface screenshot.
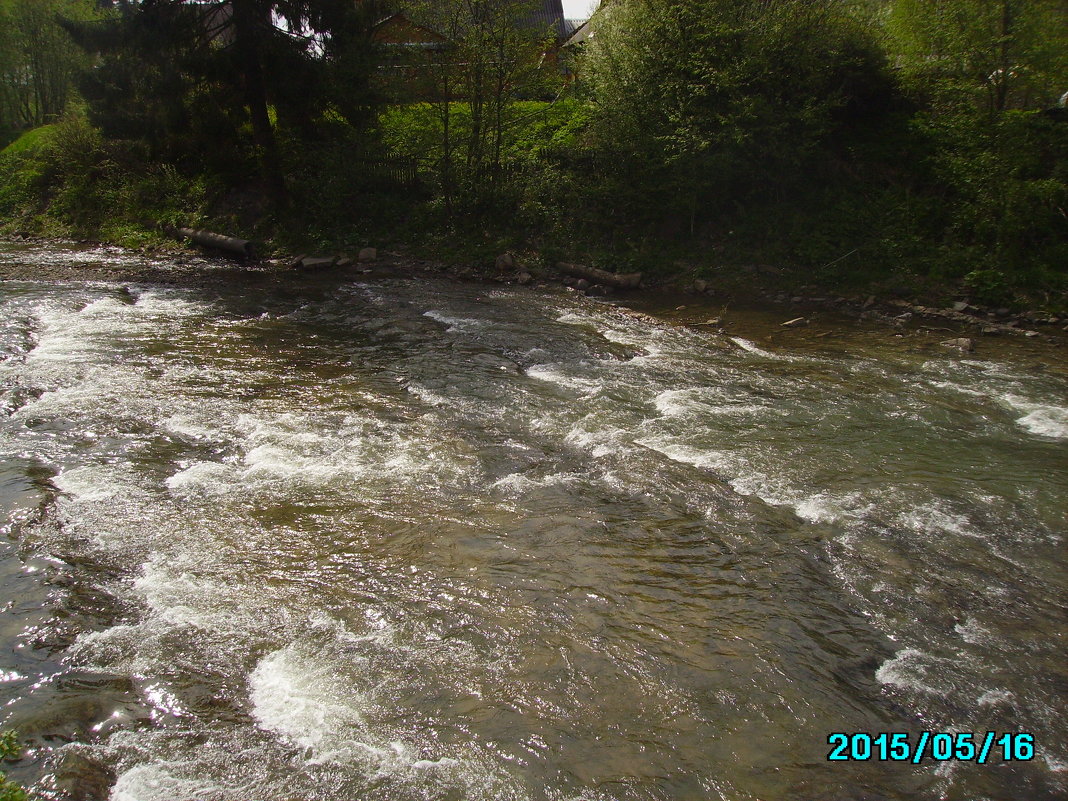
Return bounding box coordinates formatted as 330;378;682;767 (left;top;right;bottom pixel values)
583;0;891;230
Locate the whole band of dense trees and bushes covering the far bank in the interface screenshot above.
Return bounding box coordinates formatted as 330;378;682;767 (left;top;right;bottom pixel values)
0;0;1068;307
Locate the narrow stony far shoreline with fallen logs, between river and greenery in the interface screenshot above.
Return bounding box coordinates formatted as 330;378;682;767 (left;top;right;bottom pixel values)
0;237;1068;349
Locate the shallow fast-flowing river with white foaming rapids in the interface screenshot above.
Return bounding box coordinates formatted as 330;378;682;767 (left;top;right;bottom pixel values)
0;248;1068;801
